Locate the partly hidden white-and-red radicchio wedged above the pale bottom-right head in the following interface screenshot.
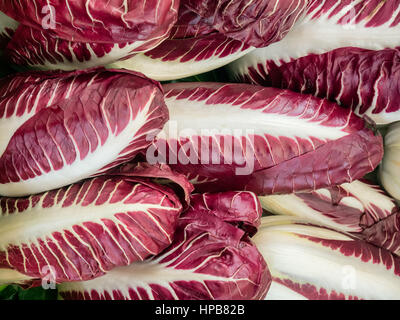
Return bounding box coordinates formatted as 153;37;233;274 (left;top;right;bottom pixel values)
260;181;400;255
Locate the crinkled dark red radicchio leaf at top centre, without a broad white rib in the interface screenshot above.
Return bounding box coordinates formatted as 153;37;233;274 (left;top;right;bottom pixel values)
182;0;307;47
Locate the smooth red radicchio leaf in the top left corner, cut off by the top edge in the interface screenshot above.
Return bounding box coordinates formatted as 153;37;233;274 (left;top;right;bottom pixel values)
0;0;179;43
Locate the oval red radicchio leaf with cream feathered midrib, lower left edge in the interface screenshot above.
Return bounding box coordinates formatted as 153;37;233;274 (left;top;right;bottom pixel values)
0;177;182;282
